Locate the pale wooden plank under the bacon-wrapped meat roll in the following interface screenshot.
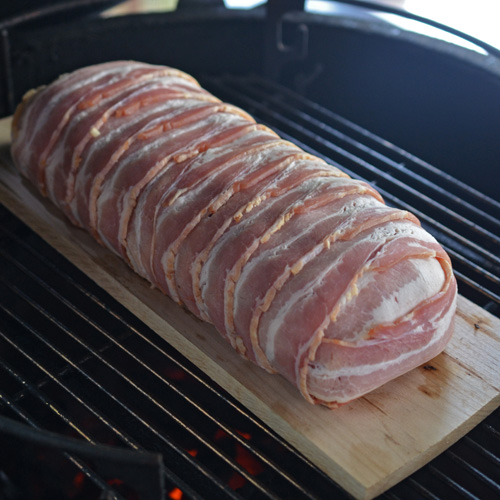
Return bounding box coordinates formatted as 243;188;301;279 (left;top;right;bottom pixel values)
0;119;500;499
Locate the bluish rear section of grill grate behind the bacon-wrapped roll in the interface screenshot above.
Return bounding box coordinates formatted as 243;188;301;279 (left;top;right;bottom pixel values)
203;77;500;315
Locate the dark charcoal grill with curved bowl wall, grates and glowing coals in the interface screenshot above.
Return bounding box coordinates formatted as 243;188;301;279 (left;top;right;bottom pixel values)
0;1;500;500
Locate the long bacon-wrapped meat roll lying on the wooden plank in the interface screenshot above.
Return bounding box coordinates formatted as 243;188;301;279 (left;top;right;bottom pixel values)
12;61;457;408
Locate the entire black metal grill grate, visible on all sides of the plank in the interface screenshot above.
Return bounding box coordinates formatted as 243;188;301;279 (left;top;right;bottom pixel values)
0;77;500;500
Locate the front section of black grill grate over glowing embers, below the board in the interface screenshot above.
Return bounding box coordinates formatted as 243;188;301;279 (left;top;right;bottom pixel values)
0;204;348;498
